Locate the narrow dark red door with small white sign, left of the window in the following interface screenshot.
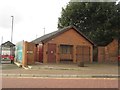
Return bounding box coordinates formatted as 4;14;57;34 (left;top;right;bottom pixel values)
48;43;56;63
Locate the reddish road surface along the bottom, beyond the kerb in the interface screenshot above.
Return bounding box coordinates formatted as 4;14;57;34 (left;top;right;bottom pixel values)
2;78;120;88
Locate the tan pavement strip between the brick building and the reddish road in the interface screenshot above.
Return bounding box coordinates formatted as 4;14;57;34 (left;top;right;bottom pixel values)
0;63;120;78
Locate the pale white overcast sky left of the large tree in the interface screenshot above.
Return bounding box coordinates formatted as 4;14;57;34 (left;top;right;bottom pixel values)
0;0;70;44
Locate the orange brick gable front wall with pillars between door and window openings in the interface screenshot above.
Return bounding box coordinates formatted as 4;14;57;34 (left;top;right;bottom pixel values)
43;29;93;63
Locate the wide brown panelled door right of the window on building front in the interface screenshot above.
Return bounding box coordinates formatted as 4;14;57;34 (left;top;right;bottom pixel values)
76;46;90;62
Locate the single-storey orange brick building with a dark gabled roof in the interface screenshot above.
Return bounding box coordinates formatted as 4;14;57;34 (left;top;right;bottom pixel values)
32;26;94;63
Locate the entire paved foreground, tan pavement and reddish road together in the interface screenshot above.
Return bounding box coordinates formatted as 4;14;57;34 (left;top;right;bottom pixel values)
0;64;120;88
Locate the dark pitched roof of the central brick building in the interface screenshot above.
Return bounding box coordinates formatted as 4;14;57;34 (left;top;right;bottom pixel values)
32;26;94;45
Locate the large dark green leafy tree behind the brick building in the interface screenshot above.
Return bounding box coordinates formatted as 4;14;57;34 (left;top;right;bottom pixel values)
58;2;120;45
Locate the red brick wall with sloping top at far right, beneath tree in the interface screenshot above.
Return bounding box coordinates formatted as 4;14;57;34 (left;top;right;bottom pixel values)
98;39;118;63
